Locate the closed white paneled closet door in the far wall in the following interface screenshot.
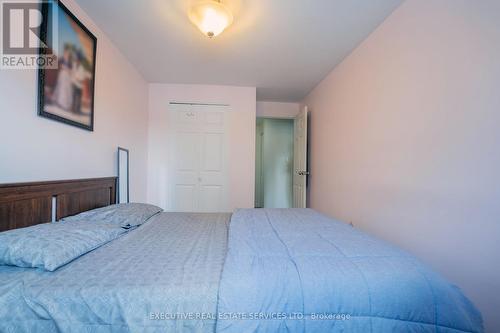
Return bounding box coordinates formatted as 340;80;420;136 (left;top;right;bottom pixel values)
167;104;229;212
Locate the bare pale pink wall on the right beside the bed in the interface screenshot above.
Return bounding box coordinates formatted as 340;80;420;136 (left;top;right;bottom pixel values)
304;0;500;332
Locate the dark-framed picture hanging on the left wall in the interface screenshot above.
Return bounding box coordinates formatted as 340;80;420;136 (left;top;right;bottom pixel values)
38;0;97;131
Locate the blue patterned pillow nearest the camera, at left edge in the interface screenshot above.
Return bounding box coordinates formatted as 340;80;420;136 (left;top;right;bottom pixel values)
0;221;127;272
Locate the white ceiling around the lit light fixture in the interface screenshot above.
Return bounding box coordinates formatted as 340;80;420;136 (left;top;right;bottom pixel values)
76;0;403;101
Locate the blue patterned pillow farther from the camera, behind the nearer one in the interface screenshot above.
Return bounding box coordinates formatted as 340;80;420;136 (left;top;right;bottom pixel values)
62;203;163;229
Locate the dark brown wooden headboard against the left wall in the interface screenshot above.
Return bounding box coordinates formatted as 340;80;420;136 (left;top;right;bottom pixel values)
0;177;116;231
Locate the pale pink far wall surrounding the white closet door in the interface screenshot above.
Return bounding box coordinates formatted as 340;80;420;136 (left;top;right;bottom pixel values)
148;84;256;209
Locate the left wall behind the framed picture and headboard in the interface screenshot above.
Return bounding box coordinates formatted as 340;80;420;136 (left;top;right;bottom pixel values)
0;0;148;201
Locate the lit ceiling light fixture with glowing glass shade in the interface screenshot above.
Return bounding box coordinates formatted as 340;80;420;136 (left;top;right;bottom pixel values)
189;0;233;38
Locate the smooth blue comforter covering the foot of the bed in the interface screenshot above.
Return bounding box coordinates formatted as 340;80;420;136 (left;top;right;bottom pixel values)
217;209;483;333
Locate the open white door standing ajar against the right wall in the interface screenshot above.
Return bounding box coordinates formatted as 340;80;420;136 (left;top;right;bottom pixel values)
293;106;309;208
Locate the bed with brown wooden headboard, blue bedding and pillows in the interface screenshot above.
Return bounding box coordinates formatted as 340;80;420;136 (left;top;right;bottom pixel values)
0;178;483;333
